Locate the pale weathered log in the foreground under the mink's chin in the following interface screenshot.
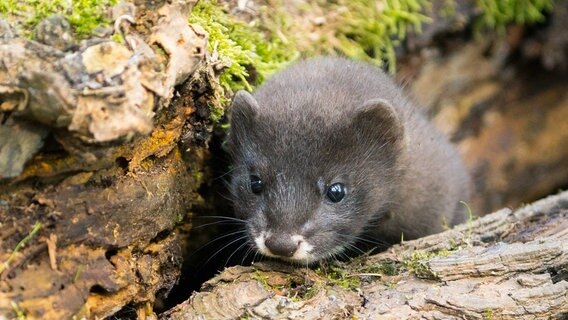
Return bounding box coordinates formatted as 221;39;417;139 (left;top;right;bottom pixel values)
162;192;568;319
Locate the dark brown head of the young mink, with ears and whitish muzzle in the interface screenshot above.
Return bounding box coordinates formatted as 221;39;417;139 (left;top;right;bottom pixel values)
228;87;404;263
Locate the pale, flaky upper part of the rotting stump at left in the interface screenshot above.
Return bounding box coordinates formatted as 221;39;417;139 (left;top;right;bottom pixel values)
0;0;207;178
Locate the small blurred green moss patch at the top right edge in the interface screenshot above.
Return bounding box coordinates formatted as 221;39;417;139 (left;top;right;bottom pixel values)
475;0;554;32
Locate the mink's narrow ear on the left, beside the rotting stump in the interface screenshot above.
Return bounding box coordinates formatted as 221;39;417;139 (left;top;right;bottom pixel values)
229;90;259;149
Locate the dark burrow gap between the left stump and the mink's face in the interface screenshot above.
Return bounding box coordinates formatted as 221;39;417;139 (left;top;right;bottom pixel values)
155;124;255;313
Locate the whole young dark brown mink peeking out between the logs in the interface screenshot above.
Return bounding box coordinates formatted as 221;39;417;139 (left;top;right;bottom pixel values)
228;58;469;263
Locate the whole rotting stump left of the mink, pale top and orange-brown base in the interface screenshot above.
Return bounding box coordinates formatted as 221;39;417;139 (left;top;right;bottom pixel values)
0;0;214;319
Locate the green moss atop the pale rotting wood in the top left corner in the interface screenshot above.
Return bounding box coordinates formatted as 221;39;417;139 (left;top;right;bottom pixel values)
0;0;117;38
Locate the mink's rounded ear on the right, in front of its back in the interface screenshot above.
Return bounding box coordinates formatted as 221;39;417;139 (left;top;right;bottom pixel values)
352;99;404;146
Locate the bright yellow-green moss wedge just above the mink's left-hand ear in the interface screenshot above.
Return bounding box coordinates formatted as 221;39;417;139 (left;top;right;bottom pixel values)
189;0;298;91
